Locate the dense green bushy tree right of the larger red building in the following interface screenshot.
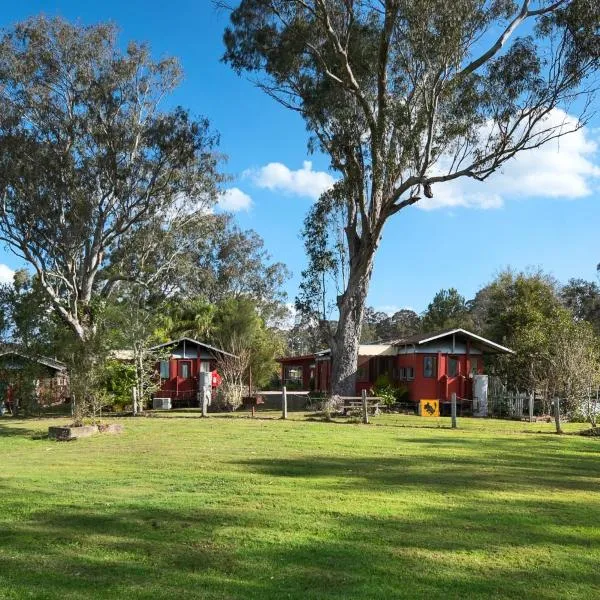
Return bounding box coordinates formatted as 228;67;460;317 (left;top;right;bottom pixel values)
473;271;600;402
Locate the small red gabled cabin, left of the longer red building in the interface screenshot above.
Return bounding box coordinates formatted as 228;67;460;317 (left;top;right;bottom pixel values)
151;337;233;408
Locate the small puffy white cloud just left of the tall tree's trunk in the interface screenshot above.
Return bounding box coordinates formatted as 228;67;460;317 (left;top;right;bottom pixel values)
244;160;335;200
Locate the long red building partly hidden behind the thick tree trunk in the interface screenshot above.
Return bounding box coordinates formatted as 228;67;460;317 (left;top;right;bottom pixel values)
279;329;513;402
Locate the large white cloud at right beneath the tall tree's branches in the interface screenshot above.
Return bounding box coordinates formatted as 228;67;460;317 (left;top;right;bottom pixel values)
417;110;600;210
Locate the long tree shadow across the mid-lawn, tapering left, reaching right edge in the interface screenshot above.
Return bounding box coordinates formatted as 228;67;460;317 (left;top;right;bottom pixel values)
237;437;600;492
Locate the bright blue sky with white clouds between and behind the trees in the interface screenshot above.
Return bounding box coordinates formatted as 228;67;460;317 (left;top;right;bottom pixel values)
0;0;600;311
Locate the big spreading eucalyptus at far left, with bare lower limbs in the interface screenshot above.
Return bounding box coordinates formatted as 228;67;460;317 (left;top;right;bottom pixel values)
0;17;220;344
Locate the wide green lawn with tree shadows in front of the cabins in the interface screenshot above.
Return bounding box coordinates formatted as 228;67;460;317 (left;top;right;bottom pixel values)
0;412;600;600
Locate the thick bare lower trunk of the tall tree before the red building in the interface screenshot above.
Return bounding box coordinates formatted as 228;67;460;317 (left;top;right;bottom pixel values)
331;249;373;396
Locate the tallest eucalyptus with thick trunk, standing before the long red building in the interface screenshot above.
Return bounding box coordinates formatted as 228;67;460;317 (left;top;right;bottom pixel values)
224;0;600;394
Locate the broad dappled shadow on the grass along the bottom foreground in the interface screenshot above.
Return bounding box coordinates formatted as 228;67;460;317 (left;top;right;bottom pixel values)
0;500;598;600
